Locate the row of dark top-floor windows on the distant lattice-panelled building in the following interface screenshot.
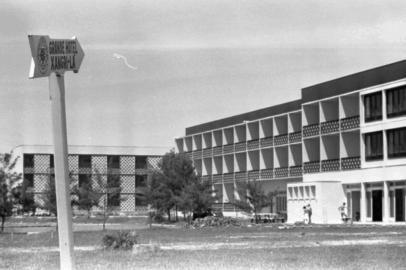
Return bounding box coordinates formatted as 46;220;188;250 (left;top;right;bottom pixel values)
24;154;147;169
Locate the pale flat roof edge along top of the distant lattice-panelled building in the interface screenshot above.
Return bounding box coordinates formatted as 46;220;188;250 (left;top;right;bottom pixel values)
13;145;170;156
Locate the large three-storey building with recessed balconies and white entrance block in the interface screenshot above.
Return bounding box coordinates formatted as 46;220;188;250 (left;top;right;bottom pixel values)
176;58;406;223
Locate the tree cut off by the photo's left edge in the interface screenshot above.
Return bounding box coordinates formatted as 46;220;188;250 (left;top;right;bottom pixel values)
0;154;21;232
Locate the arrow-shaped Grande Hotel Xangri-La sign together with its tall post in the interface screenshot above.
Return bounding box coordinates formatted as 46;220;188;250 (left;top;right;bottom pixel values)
28;35;84;270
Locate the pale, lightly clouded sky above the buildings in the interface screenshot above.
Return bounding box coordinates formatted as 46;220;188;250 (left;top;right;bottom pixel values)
0;0;406;152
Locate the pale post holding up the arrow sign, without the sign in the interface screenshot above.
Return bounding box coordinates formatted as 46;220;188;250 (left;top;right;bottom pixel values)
49;73;75;270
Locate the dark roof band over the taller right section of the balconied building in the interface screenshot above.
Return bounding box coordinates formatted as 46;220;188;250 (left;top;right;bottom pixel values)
302;60;406;103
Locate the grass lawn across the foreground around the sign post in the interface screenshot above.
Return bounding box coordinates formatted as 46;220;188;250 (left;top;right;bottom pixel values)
0;226;406;269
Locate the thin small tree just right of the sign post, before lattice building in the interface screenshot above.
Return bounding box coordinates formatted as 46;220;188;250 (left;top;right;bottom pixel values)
72;174;103;218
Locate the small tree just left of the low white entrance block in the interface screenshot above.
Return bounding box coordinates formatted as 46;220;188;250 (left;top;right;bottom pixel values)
233;180;277;223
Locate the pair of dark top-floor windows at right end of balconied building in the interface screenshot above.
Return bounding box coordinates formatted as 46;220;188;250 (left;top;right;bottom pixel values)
364;86;406;122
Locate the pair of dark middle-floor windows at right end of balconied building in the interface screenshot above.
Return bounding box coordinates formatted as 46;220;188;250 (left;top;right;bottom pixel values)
365;128;406;161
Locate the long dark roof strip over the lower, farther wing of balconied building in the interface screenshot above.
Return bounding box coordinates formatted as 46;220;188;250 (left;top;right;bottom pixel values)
186;99;302;136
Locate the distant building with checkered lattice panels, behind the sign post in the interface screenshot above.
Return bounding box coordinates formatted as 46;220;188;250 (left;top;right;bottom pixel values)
13;145;167;213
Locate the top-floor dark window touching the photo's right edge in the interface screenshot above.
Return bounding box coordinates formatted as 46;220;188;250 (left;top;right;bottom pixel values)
386;86;406;118
